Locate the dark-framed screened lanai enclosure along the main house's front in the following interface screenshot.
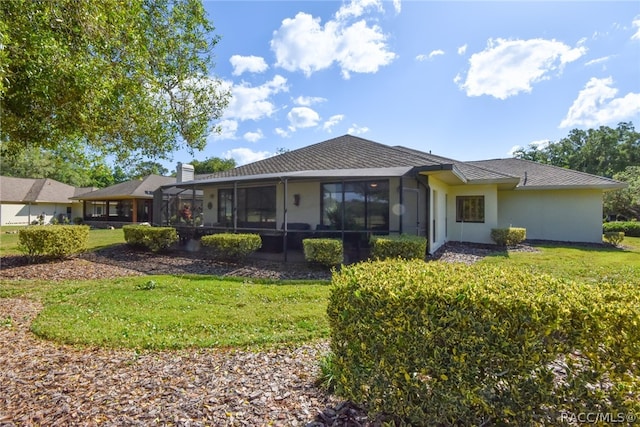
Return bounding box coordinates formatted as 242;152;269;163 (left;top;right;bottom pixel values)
154;168;425;260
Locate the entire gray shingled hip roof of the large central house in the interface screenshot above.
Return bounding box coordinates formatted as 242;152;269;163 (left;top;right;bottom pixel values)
171;135;624;189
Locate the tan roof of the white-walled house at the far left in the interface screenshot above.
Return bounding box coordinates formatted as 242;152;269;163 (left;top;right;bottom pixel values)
0;176;76;203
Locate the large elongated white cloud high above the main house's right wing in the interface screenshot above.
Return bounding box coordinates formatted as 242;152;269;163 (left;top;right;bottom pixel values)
454;39;587;99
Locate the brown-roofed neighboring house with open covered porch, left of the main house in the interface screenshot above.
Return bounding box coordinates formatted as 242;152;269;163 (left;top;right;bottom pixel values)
73;175;176;226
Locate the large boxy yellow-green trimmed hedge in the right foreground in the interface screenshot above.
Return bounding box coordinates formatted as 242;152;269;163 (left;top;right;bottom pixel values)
327;260;640;426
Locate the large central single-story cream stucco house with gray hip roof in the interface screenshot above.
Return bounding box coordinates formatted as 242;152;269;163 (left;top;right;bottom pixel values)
154;135;625;253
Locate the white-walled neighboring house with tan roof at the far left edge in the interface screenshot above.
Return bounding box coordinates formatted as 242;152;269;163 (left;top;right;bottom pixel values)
0;176;91;225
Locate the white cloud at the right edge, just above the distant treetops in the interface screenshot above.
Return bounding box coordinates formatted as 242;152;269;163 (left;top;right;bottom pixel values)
560;77;640;128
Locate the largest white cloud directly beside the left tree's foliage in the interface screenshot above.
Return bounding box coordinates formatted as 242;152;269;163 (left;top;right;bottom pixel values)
224;75;289;120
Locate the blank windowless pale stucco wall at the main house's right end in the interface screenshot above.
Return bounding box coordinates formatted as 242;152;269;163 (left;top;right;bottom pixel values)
498;190;602;243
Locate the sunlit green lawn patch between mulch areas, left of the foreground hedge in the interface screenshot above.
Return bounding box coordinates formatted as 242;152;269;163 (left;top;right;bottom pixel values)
6;276;329;349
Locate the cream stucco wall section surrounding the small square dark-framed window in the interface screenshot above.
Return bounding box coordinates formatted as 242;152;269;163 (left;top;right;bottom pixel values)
444;186;498;244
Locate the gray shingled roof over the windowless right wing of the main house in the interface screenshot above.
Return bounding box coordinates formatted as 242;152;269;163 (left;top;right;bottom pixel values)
467;159;626;190
